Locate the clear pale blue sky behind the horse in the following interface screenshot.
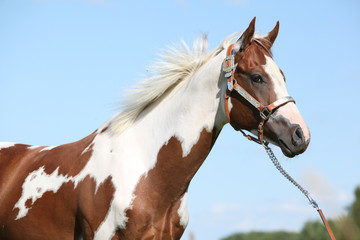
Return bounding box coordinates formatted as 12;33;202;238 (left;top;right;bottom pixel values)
0;0;360;240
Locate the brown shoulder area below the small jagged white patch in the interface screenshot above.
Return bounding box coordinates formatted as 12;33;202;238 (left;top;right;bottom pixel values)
0;176;115;240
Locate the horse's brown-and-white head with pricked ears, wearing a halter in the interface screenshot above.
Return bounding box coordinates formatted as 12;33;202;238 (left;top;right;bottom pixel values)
224;18;310;157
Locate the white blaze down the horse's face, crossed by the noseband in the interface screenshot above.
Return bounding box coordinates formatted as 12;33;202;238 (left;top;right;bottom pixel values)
263;56;310;141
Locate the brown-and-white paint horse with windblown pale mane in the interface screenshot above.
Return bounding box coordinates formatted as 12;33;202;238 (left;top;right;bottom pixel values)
0;18;310;240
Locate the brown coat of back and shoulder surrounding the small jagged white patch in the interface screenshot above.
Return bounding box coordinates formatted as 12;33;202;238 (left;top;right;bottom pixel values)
0;133;115;240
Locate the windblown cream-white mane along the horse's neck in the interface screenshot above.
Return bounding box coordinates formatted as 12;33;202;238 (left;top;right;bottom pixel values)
110;33;237;133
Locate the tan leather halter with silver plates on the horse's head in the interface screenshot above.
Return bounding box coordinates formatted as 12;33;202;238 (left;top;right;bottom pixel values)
223;40;295;144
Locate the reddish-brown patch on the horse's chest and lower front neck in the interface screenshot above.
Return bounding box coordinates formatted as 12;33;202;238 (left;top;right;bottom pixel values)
118;129;217;239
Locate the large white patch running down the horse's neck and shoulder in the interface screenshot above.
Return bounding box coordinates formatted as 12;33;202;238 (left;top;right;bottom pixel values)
93;49;226;239
